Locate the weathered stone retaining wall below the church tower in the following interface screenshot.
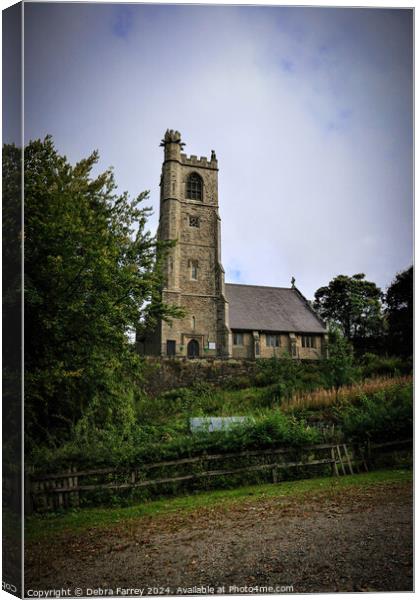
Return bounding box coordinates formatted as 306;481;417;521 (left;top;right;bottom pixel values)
145;357;257;396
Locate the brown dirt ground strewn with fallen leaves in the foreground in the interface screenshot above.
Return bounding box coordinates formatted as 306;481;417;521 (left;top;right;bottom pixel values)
25;483;413;596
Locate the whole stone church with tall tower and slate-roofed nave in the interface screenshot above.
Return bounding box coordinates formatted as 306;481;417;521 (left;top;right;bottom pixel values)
139;130;327;360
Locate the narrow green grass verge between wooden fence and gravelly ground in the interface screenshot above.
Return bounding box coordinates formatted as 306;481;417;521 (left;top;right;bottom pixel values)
25;469;412;542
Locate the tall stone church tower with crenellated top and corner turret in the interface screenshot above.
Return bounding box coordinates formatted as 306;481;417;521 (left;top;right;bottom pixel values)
149;130;231;358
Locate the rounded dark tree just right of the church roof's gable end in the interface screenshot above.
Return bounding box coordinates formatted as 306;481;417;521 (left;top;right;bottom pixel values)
314;273;383;340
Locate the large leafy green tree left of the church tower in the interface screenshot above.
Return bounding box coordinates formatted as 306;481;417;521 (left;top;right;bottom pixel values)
21;137;178;443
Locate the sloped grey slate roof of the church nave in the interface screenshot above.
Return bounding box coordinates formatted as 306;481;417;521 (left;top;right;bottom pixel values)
225;283;326;333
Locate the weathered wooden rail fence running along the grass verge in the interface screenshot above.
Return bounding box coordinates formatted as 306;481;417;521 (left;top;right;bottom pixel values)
26;440;412;513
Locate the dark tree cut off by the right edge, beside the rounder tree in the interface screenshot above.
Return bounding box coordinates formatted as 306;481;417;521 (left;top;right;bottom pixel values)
385;267;413;356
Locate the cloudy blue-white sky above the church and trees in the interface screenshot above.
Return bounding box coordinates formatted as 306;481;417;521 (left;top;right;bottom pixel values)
17;3;413;298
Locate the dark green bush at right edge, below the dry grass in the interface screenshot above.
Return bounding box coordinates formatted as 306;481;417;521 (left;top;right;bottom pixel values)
338;385;413;442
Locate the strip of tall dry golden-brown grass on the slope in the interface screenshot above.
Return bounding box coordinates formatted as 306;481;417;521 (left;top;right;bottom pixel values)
284;375;413;412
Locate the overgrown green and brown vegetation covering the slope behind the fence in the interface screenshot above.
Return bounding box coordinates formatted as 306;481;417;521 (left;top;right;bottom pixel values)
33;368;412;470
